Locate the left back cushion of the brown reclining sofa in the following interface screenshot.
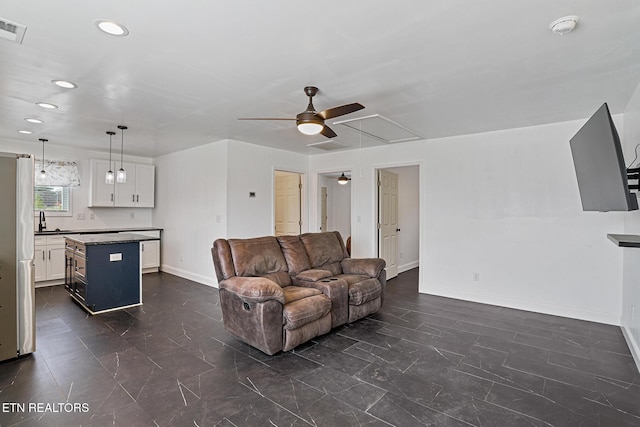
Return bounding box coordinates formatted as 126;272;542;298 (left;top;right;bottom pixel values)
228;236;289;286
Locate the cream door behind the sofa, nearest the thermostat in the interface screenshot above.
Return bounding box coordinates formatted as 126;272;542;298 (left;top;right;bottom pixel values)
275;171;302;236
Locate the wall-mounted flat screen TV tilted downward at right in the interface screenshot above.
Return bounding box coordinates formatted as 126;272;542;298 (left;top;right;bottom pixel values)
569;102;638;212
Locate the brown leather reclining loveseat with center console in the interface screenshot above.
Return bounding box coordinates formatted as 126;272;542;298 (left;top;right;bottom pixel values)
211;232;386;354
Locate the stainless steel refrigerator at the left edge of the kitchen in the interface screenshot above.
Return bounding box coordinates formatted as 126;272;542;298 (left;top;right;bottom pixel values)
0;153;36;360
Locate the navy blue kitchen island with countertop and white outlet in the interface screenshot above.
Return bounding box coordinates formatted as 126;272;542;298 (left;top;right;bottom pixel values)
65;233;157;314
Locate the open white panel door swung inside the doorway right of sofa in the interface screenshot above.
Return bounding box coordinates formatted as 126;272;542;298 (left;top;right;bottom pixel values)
378;169;400;279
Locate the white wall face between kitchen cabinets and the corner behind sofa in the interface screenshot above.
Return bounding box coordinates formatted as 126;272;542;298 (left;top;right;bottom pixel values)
153;141;228;286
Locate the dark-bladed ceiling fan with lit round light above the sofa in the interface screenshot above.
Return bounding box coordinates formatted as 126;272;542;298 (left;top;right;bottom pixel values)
238;86;364;138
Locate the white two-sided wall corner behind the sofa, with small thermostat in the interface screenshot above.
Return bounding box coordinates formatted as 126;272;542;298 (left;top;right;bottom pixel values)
153;140;308;286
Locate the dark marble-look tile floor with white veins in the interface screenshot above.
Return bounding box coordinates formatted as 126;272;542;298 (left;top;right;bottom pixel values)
0;270;640;427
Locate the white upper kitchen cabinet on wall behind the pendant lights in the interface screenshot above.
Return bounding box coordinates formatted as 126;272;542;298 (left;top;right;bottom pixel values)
89;160;155;208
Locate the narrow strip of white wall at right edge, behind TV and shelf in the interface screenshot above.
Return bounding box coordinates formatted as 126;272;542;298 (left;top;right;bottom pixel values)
618;85;640;369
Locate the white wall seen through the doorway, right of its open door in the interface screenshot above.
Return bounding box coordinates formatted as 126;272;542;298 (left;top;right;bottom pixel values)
386;166;420;273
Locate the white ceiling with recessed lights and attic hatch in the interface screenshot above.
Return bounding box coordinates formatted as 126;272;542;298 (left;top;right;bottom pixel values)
0;0;640;157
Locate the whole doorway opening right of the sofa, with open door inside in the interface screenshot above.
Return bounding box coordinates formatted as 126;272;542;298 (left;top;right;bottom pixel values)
376;165;420;279
